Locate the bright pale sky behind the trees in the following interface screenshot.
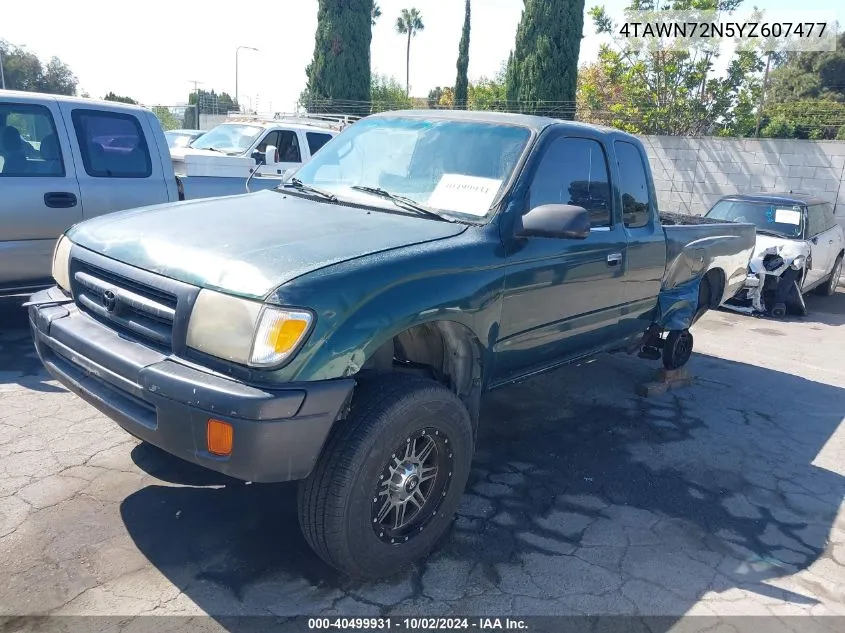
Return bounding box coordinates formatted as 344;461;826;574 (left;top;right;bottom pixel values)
0;0;842;112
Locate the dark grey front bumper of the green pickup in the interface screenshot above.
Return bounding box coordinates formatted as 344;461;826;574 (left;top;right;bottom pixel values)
29;288;355;482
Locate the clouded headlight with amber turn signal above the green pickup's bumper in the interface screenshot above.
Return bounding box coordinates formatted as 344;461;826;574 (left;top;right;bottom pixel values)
187;290;314;367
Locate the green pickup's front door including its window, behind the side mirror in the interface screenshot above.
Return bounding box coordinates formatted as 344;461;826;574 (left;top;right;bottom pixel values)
494;135;627;382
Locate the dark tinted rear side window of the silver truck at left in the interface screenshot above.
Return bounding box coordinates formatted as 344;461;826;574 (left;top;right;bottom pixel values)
71;109;153;178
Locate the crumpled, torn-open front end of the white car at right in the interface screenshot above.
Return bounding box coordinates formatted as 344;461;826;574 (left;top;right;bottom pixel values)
725;236;810;318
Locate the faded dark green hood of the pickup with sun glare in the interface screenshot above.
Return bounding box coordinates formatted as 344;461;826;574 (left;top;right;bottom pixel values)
68;191;467;298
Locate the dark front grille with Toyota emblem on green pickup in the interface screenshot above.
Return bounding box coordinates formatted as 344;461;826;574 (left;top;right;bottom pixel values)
71;259;176;351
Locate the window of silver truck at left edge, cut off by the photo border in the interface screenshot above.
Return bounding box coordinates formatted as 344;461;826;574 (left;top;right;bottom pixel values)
0;103;65;178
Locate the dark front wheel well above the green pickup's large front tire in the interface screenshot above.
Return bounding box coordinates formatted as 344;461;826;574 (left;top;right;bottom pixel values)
359;321;483;425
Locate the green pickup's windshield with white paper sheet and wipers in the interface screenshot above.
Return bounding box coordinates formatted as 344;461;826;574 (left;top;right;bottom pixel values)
296;117;531;219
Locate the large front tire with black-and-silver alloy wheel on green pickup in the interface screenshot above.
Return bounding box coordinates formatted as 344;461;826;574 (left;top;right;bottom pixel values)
298;374;473;578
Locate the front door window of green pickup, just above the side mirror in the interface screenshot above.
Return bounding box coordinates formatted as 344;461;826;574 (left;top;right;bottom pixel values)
528;138;611;227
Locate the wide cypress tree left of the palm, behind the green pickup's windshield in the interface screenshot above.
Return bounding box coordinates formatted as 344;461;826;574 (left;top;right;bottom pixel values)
305;0;373;114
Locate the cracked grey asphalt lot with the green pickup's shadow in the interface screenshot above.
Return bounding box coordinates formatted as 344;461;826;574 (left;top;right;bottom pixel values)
0;290;845;630
